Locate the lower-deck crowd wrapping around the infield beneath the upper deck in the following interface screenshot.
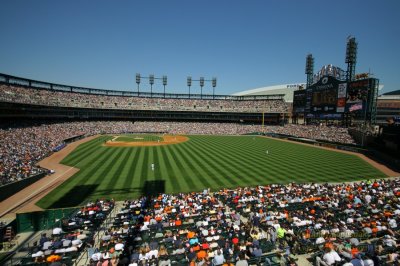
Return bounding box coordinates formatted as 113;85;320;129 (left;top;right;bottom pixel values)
0;121;354;185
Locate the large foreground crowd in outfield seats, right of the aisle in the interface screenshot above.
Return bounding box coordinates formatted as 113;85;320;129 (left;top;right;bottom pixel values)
82;179;400;266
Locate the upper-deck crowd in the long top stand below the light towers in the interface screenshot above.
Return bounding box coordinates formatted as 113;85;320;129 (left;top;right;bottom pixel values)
0;85;288;113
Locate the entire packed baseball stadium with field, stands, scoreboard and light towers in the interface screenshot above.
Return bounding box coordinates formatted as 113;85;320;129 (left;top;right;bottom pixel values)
0;3;400;266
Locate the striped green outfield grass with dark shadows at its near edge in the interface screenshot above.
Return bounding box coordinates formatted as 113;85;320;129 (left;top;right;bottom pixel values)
38;136;385;208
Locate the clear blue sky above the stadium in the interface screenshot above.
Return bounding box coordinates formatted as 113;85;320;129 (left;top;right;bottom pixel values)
0;0;400;94
